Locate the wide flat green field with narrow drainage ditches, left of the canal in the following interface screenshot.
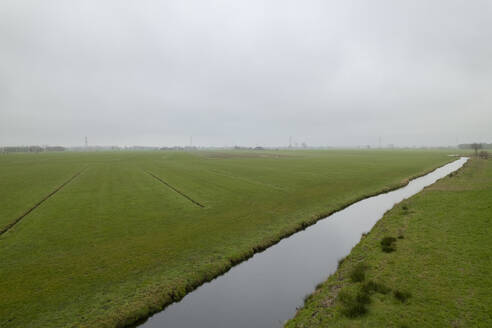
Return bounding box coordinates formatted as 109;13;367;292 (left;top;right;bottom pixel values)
0;150;454;328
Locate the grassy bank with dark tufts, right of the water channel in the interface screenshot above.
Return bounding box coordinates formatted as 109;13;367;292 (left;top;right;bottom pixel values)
286;159;492;328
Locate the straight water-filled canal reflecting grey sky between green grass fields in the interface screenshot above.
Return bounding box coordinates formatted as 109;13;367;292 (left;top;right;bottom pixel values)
140;157;467;328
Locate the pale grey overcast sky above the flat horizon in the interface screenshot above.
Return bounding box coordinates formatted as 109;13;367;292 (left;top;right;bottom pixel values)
0;0;492;146
